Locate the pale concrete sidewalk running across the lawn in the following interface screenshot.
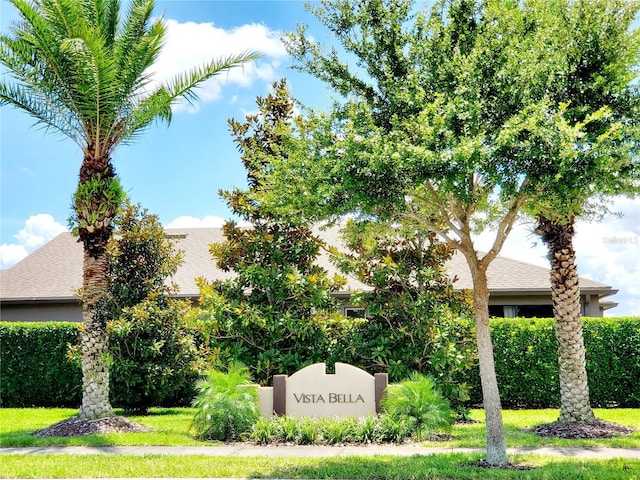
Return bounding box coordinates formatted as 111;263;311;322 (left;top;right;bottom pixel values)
0;443;640;460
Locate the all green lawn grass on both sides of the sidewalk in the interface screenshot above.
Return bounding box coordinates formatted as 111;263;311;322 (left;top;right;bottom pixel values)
0;409;640;480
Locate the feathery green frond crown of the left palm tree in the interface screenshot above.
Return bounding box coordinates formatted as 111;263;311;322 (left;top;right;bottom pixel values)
0;0;259;154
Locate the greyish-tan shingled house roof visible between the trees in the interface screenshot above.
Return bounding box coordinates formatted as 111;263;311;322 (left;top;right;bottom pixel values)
0;228;617;302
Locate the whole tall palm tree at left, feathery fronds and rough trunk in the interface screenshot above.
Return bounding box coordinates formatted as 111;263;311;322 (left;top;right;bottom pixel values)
0;0;258;420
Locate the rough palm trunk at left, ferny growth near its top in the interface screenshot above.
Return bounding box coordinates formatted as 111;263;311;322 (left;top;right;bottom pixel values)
74;155;120;420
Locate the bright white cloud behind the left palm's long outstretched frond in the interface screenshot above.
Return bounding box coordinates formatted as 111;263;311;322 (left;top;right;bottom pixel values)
153;19;287;112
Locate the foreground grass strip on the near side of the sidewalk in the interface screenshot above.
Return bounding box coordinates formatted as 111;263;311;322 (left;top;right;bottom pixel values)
0;454;640;480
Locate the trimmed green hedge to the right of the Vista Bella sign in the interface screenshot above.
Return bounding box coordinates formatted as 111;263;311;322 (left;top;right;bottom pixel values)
466;317;640;408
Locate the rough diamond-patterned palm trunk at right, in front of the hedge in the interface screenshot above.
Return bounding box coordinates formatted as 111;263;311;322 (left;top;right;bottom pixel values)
536;216;595;423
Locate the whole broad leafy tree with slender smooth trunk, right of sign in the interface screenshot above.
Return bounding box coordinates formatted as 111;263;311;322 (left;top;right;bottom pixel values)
258;0;640;464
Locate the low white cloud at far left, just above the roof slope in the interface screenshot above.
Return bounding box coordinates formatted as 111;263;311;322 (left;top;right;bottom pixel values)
0;213;67;268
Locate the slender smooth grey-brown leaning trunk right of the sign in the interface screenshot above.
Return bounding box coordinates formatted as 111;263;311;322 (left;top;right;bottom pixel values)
467;258;507;466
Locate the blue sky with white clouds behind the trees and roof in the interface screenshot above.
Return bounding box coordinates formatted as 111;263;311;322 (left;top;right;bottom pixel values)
0;0;640;315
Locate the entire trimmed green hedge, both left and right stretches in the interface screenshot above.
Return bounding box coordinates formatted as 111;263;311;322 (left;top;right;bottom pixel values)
0;317;640;408
